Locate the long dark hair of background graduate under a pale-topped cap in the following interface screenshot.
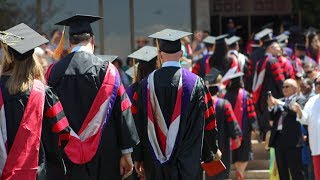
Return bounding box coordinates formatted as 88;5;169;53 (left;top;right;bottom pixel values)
209;41;228;72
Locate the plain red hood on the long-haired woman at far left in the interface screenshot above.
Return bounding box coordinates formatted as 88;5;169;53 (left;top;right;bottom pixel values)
0;80;45;180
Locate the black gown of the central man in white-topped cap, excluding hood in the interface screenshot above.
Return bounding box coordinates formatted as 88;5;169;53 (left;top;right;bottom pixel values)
134;67;217;180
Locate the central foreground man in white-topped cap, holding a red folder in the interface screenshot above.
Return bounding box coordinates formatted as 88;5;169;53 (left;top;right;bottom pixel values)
134;29;221;180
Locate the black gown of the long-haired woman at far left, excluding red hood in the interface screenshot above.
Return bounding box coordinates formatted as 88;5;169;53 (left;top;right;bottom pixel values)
0;76;70;180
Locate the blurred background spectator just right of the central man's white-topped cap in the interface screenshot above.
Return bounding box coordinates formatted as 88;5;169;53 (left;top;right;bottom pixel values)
191;30;206;63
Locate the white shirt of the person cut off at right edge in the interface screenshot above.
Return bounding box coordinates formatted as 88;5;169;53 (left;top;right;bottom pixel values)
297;94;320;156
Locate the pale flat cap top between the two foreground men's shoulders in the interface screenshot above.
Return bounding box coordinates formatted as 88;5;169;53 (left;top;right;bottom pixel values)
128;46;158;62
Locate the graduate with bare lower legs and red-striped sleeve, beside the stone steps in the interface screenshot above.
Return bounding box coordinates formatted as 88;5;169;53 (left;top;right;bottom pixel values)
224;72;258;180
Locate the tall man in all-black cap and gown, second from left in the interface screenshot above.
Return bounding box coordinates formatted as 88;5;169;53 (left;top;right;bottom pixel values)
47;15;139;180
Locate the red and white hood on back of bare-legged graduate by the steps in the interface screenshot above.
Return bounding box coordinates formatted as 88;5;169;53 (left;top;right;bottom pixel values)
231;88;247;150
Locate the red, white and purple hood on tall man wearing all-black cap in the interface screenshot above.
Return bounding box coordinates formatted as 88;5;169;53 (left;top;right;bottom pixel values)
64;63;124;164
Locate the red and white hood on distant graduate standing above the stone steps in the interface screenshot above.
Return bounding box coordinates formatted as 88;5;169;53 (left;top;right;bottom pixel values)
252;56;270;104
